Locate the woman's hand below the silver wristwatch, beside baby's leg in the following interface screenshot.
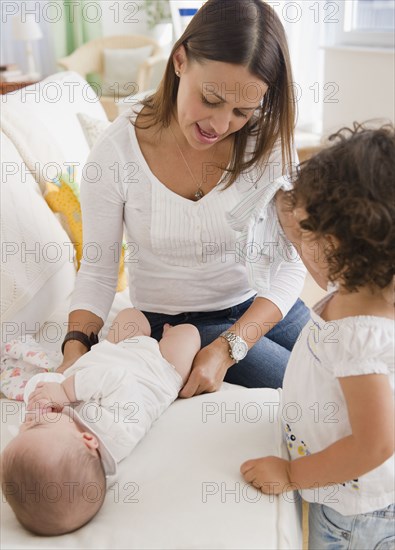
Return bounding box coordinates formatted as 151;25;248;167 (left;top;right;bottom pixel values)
179;338;233;397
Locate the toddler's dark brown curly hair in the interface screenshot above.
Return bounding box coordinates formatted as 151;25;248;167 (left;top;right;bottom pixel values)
287;125;395;292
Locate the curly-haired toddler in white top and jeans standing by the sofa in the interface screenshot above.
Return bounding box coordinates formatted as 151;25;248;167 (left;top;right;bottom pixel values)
241;127;395;550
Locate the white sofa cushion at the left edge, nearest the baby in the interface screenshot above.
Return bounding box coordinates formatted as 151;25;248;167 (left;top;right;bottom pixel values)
1;133;76;345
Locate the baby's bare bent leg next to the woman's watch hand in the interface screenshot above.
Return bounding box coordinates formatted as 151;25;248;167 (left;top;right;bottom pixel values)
159;324;201;383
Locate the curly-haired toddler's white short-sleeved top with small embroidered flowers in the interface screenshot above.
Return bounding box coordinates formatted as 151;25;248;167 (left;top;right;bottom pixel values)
282;296;395;515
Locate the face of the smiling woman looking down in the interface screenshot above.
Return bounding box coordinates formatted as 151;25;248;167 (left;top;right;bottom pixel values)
173;46;268;149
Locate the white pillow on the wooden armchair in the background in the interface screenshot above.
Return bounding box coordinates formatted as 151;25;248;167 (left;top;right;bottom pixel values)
102;46;153;97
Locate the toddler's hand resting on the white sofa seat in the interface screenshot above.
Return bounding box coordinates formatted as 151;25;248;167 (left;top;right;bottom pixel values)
240;456;295;495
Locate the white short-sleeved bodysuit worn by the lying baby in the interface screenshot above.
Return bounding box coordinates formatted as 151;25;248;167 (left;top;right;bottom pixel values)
24;336;182;481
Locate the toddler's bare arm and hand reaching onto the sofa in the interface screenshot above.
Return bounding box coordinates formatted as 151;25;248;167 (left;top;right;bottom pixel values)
241;374;394;494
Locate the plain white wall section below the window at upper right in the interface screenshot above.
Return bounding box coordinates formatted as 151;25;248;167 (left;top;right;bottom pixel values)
323;47;395;135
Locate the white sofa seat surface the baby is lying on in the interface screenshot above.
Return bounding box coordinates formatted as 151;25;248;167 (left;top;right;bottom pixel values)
0;385;302;550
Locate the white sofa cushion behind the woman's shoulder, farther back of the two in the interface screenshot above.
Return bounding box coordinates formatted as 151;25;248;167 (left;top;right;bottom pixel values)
1;71;107;195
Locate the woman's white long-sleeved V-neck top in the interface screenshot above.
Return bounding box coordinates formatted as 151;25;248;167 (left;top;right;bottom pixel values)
70;105;305;320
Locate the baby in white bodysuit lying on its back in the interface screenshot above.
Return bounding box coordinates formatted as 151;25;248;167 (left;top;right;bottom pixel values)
1;309;200;535
